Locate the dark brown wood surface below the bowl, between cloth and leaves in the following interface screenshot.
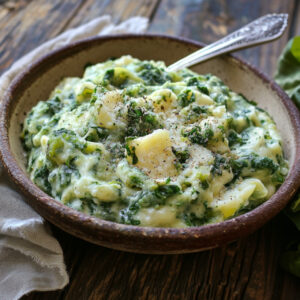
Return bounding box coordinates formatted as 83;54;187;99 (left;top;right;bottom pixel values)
23;215;299;300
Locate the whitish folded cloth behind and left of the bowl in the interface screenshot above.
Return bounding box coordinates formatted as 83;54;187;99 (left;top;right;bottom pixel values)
0;16;148;300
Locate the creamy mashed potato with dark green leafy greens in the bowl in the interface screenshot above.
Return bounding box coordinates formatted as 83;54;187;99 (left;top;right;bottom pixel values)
22;56;288;227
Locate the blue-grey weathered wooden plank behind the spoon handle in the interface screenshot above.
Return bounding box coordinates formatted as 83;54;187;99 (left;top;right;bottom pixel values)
149;0;299;75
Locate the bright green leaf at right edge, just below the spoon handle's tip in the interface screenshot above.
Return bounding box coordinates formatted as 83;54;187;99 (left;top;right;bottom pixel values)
275;36;300;109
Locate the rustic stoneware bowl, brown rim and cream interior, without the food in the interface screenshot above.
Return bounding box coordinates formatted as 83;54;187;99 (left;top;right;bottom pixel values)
0;35;300;254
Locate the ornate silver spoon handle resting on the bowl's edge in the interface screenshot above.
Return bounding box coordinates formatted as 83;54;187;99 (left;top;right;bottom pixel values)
167;14;288;71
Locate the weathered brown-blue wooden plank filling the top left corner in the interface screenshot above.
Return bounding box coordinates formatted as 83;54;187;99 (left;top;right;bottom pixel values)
0;0;83;73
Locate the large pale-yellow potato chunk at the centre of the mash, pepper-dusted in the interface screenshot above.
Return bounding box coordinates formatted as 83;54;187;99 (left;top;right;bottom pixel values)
127;129;177;178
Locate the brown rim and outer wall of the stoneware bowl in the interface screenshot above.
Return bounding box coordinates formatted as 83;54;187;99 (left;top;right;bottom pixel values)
0;34;300;253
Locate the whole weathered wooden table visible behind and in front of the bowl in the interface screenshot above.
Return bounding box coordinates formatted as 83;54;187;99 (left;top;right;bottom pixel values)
0;0;300;300
